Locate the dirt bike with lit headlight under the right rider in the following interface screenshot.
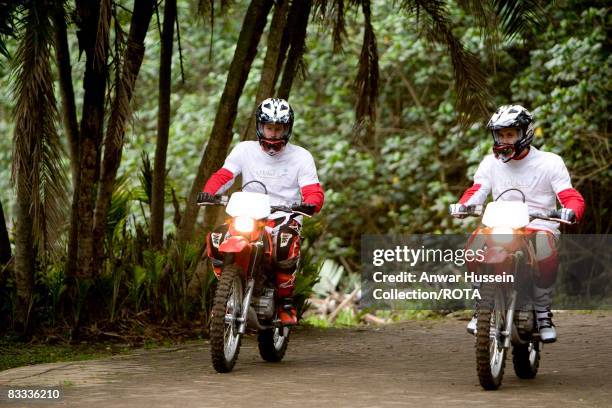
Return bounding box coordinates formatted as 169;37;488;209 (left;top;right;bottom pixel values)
464;189;570;390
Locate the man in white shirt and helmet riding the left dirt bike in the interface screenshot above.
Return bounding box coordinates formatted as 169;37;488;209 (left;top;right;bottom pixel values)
198;98;324;325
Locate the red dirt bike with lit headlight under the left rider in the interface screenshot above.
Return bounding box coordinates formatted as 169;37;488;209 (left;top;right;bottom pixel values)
198;181;310;373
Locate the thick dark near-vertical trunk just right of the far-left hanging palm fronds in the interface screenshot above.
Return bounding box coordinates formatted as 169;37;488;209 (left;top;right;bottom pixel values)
74;0;111;278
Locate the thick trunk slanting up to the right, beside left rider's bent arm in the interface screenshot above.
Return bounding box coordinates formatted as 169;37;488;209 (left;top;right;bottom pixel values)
177;0;273;242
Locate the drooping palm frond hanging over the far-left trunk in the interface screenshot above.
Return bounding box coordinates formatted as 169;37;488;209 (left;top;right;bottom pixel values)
12;2;68;255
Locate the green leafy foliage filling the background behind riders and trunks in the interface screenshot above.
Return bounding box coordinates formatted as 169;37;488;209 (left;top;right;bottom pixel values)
0;0;612;334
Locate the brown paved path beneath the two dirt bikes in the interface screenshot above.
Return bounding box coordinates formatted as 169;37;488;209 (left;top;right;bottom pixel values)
0;312;612;408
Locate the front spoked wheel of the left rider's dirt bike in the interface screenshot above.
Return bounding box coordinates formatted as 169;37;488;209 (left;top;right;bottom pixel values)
210;264;244;373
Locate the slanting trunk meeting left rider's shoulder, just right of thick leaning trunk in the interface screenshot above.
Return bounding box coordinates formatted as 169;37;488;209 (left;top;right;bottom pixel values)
241;0;289;140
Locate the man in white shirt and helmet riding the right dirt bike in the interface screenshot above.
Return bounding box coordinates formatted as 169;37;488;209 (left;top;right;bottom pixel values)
450;105;585;343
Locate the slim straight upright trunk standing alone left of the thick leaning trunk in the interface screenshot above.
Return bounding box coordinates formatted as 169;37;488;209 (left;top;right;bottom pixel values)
151;0;176;248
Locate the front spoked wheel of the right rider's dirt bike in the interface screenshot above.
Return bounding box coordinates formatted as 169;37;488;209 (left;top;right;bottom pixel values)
476;286;506;390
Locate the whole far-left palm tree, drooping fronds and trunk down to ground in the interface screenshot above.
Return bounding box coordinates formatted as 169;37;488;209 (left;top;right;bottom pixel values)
12;1;66;329
